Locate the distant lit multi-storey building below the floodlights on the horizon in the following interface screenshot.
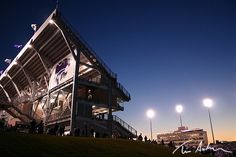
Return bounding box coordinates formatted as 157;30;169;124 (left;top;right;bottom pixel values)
157;126;208;147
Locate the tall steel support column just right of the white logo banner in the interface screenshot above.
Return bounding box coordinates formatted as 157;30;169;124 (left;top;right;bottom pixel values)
70;49;80;135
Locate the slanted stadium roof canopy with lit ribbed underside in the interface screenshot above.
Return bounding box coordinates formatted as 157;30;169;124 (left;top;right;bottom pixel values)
0;10;129;104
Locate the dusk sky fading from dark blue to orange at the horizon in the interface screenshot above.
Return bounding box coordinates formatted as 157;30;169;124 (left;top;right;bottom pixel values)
0;0;236;140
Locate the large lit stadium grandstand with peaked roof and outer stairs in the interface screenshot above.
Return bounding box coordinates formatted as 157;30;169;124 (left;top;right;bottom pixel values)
0;9;137;138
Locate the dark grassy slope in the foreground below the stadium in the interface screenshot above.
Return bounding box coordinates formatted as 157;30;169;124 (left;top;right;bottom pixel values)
0;132;205;157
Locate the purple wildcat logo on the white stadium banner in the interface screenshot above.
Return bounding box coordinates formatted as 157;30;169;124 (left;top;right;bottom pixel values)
55;58;70;84
